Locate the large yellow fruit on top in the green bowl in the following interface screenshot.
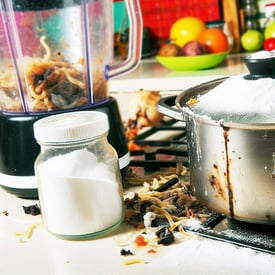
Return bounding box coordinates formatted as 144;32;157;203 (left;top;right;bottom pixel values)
170;16;206;47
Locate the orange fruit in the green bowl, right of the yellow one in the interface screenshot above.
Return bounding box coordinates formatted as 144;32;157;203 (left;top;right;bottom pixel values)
198;28;229;53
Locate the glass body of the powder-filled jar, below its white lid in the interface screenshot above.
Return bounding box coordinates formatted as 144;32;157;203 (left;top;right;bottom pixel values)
35;133;124;240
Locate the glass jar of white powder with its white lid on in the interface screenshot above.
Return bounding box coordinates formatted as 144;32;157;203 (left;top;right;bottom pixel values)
34;111;124;240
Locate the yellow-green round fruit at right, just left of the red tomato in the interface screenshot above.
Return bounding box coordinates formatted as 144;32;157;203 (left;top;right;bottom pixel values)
241;30;264;52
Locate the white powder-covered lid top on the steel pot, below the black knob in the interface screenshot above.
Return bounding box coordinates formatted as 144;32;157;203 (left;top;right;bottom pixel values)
191;75;275;123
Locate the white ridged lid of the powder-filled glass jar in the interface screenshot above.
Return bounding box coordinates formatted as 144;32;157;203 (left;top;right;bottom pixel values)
33;111;109;142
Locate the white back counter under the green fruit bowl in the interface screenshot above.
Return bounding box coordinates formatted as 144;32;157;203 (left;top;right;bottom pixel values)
110;54;248;93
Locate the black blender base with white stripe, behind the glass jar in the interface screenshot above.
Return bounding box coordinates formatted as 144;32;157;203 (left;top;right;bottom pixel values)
0;97;130;199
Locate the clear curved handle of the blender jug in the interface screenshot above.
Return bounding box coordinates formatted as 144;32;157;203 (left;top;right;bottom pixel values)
105;0;143;80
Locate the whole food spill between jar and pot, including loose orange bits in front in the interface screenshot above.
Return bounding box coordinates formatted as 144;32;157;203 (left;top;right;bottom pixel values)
118;163;211;265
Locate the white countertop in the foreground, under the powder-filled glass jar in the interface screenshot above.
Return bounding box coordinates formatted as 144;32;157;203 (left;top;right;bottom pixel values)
0;190;275;275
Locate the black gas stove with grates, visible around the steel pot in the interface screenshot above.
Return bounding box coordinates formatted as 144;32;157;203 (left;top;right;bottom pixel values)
130;119;275;254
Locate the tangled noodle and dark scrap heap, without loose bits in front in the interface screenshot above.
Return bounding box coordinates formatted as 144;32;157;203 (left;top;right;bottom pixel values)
124;165;211;229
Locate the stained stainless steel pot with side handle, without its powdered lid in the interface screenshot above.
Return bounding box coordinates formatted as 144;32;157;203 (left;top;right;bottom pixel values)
158;78;275;224
